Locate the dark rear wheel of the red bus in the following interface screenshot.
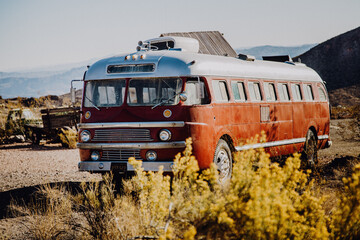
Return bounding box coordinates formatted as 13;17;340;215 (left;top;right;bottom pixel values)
302;130;318;168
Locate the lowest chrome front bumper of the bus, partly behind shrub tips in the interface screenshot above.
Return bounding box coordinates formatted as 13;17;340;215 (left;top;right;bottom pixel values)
78;161;174;172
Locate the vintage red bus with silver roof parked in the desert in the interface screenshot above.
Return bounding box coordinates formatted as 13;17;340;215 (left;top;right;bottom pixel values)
77;33;331;180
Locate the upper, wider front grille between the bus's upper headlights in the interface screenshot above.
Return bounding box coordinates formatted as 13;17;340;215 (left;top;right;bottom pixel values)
92;129;152;142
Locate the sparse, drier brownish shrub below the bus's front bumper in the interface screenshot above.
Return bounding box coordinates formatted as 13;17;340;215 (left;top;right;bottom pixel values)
69;174;145;239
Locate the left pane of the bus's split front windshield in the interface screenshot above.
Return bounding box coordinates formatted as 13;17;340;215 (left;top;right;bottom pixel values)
84;79;126;108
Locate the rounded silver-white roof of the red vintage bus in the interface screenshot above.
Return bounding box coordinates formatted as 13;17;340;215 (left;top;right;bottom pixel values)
85;49;322;82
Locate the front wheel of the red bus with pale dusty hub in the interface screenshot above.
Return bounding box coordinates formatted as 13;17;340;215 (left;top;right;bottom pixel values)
214;139;233;183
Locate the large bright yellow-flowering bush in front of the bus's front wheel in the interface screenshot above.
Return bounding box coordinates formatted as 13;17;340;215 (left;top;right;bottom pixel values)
124;139;328;239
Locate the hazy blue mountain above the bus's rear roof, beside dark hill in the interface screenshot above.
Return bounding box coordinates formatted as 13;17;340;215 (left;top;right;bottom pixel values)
235;44;316;60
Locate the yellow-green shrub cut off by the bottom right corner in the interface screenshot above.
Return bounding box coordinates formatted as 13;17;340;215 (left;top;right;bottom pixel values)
332;164;360;239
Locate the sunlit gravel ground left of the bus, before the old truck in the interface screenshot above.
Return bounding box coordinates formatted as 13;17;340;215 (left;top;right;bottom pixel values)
0;143;101;192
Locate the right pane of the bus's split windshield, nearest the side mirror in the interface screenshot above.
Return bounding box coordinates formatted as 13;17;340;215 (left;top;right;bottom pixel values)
127;78;182;106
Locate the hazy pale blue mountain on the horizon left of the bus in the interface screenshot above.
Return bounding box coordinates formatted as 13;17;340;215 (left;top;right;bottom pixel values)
0;66;86;98
